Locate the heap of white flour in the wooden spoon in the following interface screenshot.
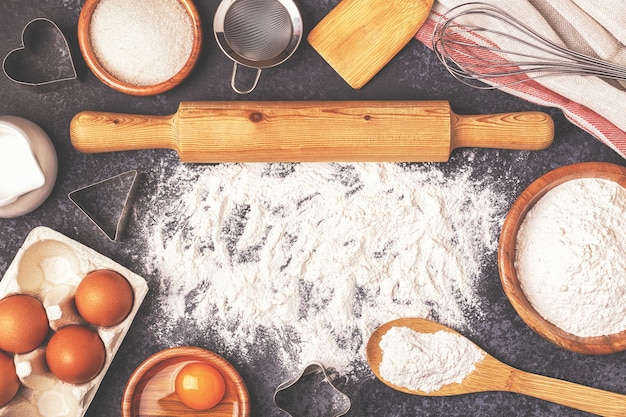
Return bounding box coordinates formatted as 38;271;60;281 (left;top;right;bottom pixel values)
380;327;485;393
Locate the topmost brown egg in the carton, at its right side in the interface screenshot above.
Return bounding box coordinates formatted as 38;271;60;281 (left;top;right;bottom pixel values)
75;269;134;327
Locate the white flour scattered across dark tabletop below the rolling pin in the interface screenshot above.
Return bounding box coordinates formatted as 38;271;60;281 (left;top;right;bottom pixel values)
138;163;504;373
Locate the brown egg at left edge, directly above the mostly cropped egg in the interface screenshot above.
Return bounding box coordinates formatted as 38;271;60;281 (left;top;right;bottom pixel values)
0;294;49;353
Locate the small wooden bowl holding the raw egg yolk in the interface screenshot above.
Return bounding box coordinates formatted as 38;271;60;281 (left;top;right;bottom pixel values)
122;346;250;417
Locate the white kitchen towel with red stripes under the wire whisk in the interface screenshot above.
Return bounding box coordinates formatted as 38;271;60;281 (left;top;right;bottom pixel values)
416;0;626;158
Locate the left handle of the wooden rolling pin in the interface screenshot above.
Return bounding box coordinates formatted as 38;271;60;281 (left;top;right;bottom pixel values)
70;111;178;153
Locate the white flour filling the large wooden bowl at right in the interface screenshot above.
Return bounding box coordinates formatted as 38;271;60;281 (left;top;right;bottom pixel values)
515;178;626;337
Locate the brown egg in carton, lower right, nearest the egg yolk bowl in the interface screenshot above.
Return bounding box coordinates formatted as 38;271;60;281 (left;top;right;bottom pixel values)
46;324;106;385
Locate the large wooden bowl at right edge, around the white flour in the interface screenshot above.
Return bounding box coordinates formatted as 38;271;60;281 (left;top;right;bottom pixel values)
498;162;626;355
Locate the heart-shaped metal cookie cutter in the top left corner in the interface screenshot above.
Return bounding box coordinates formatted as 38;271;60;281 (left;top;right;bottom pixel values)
2;17;78;91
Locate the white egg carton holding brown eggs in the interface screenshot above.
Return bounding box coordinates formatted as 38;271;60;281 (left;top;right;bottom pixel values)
0;227;148;417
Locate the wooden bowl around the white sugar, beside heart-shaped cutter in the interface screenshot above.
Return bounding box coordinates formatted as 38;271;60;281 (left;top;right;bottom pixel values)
78;0;202;96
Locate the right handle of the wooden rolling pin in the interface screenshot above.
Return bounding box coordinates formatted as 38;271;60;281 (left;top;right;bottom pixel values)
452;111;554;151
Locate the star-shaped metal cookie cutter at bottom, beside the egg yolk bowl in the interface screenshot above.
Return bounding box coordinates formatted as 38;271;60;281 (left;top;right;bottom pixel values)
273;361;352;417
